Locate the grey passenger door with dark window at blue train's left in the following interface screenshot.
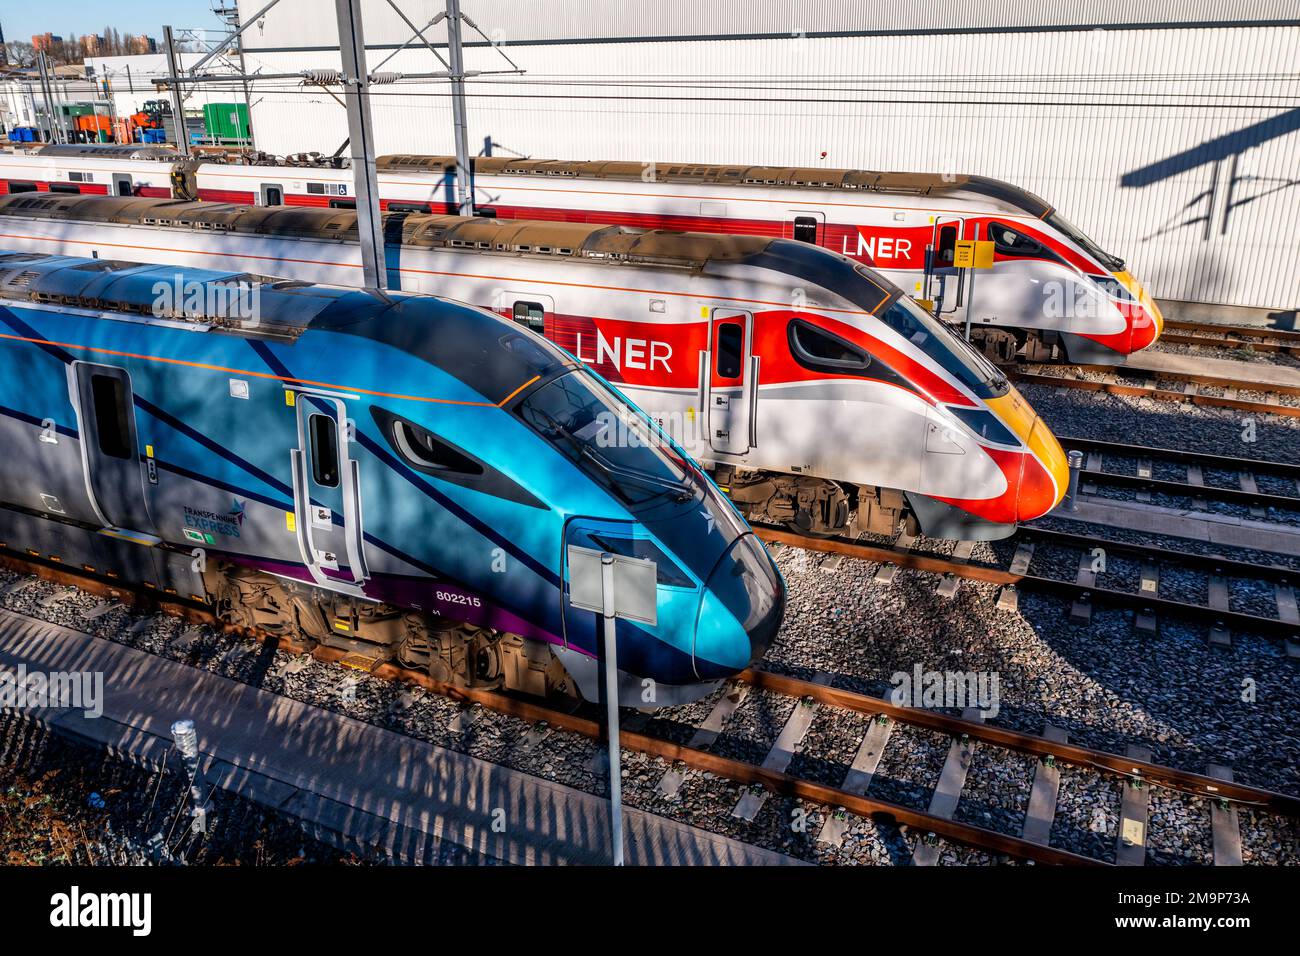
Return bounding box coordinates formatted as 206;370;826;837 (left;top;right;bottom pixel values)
69;362;155;535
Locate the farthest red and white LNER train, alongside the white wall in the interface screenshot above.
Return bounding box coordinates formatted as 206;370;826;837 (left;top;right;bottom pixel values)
0;146;1162;364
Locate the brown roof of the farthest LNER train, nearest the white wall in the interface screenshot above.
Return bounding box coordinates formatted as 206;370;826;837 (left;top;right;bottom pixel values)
376;153;1052;217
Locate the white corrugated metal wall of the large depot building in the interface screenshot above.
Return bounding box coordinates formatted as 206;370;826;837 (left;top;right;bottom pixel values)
236;0;1300;308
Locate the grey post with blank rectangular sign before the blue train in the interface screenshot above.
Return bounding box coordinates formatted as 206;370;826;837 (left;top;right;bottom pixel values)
568;545;659;866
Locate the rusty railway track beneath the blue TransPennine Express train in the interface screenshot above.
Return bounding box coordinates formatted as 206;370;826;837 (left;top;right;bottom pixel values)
0;538;1300;866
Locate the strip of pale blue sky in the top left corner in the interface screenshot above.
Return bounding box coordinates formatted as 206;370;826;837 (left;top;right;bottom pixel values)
0;0;221;40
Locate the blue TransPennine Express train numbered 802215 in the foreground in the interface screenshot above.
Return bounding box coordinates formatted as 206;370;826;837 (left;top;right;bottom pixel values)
0;252;784;706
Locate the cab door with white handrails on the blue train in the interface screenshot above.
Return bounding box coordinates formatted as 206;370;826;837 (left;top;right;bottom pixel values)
290;392;369;596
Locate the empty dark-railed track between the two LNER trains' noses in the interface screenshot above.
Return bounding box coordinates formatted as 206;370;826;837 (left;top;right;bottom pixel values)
1058;436;1300;518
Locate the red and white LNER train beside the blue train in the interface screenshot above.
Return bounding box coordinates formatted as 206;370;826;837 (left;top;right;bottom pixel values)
0;195;1067;538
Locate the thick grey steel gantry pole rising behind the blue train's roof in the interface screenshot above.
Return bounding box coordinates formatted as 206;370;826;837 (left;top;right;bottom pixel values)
334;0;389;289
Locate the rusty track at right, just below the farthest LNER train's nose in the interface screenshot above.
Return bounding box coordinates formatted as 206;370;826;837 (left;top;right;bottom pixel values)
1004;365;1300;418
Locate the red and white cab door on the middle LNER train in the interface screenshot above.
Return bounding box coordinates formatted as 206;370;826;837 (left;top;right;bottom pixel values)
699;308;758;455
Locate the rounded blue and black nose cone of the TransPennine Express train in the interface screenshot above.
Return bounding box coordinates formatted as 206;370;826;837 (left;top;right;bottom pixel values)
694;533;785;680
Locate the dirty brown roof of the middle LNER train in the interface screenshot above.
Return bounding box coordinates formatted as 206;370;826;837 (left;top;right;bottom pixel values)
0;193;776;269
